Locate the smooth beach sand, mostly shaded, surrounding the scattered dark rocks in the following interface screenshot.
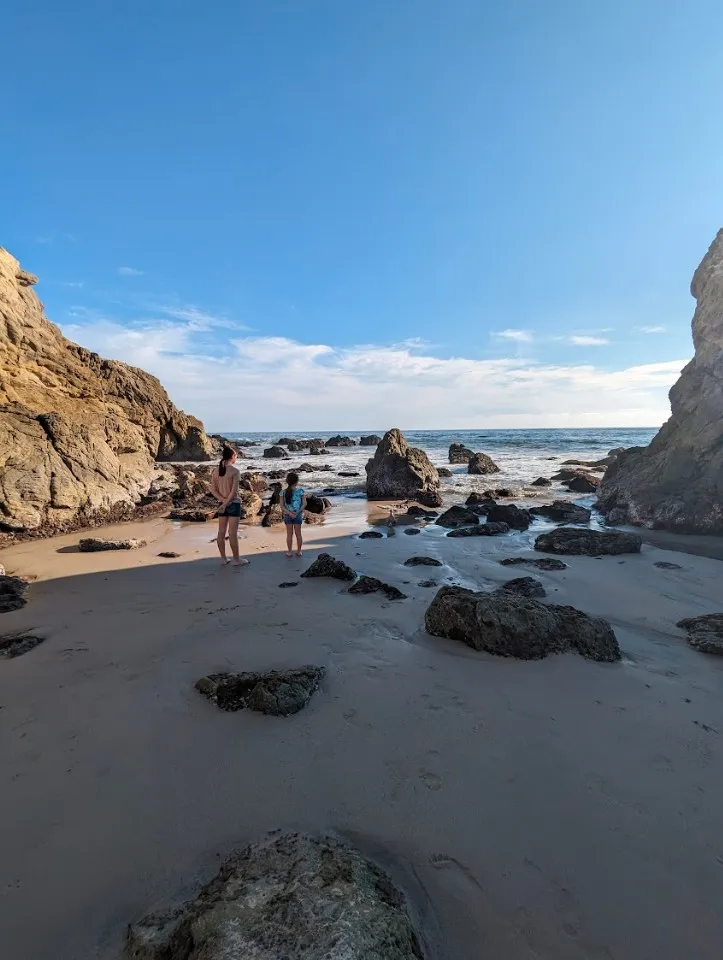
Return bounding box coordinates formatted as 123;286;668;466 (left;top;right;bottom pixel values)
0;503;723;960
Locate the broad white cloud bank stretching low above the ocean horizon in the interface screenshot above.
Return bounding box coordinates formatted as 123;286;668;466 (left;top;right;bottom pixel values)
59;314;687;431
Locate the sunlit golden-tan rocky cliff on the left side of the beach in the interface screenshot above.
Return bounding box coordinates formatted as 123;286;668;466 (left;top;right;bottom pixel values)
0;247;216;533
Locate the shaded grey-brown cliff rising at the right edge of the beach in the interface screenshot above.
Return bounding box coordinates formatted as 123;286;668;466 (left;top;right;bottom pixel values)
599;230;723;534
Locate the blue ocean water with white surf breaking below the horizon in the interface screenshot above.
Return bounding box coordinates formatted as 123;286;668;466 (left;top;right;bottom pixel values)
227;427;657;499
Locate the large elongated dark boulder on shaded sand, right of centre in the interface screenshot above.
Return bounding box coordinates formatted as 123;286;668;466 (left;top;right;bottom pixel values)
424;587;620;662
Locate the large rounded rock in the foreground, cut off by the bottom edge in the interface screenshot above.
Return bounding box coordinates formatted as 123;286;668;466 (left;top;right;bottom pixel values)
125;833;424;960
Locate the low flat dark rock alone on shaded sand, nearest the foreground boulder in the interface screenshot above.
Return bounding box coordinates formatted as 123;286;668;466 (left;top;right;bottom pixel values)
196;666;325;717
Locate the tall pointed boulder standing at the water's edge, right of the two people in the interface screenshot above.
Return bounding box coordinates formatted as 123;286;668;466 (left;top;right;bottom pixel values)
366;429;442;507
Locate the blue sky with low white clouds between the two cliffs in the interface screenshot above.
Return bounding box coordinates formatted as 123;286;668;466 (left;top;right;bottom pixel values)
0;0;723;430
